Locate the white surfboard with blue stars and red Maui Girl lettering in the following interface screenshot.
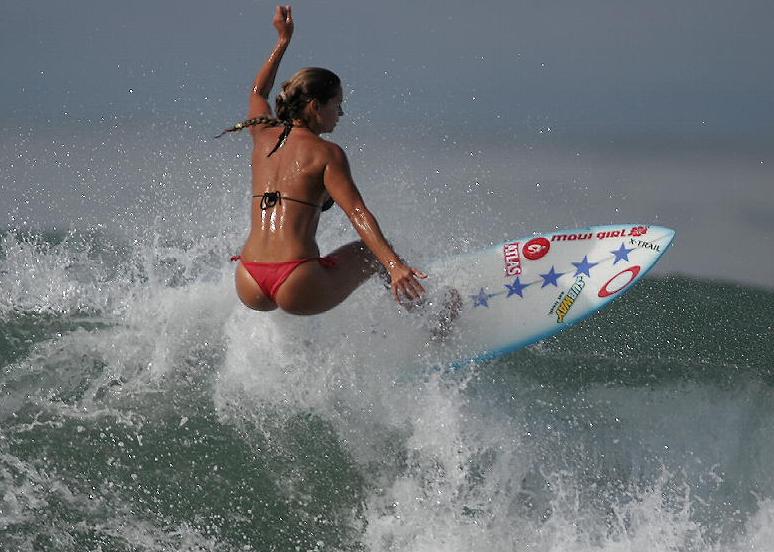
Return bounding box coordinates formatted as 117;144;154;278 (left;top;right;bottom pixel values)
418;224;675;362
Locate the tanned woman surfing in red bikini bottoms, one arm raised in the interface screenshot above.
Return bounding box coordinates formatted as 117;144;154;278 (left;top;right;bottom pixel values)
218;6;427;314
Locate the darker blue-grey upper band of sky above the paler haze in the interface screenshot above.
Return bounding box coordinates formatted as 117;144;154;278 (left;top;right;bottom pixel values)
0;0;774;135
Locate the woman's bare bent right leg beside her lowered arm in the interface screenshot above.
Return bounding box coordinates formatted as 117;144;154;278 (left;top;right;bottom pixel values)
275;241;381;314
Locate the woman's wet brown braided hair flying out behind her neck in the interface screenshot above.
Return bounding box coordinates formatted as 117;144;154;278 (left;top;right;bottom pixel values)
215;67;341;147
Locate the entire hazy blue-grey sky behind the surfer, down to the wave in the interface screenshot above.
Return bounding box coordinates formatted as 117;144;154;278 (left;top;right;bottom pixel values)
0;0;774;287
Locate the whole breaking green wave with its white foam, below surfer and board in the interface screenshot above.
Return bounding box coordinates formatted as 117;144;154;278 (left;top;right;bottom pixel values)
0;225;774;552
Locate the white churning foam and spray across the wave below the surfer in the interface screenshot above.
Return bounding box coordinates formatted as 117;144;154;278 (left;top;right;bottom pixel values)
0;144;774;552
